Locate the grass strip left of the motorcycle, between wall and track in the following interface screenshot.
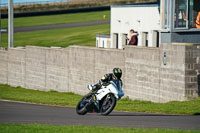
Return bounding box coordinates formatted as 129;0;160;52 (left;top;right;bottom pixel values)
0;85;81;107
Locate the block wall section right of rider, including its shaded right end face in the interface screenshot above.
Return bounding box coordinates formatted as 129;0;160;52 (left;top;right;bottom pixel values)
125;44;200;102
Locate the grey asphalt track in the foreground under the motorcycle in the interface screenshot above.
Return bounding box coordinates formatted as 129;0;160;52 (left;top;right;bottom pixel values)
0;100;200;130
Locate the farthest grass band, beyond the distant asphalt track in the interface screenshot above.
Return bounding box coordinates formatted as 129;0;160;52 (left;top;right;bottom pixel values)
2;11;110;28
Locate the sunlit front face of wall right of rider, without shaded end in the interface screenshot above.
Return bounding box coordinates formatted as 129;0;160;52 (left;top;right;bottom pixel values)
125;44;186;102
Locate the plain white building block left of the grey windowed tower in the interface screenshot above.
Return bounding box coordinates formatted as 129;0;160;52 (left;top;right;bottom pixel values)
111;4;160;49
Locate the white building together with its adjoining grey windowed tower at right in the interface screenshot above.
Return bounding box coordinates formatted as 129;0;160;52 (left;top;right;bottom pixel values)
97;0;200;49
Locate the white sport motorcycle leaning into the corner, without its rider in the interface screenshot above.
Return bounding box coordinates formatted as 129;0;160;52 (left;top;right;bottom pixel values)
76;80;124;115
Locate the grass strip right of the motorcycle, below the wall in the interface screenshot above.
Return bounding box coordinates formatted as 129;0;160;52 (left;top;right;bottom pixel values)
115;97;200;115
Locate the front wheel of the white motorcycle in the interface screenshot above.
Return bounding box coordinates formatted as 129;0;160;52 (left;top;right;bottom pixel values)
100;94;116;115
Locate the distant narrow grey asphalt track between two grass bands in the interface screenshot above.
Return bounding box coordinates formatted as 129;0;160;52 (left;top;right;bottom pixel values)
1;20;110;33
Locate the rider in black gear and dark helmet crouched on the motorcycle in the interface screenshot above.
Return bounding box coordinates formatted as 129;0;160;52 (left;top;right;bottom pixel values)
92;68;122;91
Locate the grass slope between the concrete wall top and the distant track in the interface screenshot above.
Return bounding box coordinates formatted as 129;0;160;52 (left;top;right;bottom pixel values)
2;24;110;47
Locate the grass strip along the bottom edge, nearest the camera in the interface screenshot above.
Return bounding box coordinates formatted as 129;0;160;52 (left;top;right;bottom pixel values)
0;124;200;133
